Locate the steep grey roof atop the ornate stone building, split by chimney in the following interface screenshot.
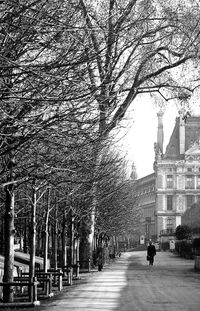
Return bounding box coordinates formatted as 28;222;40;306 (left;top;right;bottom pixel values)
164;116;200;159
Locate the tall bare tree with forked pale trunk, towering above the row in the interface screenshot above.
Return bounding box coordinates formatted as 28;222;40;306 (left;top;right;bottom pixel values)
77;0;199;260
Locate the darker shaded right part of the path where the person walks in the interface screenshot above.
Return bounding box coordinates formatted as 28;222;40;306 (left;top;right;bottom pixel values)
115;252;200;311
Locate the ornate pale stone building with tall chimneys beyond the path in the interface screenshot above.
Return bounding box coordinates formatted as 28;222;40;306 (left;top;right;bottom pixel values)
136;111;200;244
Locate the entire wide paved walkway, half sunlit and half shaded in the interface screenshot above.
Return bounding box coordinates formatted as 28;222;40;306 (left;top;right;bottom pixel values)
29;251;200;311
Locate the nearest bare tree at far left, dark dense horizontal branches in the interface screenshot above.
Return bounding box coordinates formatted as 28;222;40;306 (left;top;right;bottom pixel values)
0;0;97;302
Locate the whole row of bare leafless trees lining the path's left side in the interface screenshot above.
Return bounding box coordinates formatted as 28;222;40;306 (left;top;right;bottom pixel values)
0;0;200;301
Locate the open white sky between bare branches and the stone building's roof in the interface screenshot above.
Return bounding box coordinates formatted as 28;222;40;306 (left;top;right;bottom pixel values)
121;97;178;178
